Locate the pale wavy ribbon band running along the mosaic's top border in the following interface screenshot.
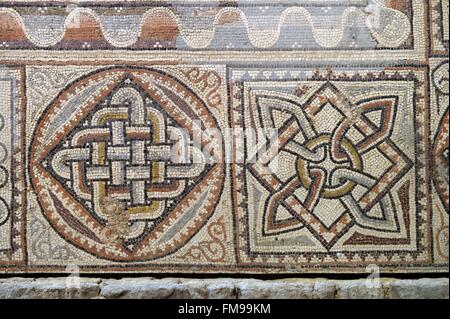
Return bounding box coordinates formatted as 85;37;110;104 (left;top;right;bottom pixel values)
0;0;411;49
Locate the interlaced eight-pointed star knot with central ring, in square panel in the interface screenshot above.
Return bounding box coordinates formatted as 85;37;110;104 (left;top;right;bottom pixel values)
248;82;413;249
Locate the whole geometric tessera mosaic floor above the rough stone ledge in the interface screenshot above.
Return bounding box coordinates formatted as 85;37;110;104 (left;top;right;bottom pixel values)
0;0;449;274
